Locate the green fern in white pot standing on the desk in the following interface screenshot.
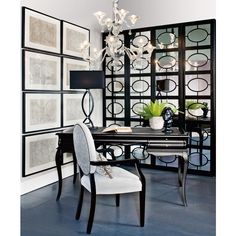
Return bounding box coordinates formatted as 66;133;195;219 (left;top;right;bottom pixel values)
138;100;175;130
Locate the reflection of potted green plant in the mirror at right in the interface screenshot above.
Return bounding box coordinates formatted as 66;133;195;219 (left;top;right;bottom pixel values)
185;100;207;118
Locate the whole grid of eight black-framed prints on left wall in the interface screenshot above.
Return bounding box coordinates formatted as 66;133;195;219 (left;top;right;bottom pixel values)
21;7;90;177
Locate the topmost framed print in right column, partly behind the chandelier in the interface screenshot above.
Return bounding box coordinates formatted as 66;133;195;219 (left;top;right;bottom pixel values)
62;21;90;58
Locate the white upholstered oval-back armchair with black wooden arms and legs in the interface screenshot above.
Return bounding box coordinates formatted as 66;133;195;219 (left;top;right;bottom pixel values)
73;122;145;234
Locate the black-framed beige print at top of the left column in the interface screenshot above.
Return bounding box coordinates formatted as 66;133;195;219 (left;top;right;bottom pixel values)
22;7;61;53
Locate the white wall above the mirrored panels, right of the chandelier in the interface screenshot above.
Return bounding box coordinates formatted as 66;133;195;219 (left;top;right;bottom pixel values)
119;0;216;28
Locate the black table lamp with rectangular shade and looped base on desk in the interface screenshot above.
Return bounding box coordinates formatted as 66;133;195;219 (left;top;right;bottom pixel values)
70;70;105;129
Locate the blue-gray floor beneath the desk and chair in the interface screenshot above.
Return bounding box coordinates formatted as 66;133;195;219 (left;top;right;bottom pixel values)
21;169;216;236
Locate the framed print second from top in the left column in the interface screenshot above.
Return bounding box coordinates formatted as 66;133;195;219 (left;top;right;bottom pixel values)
22;51;61;90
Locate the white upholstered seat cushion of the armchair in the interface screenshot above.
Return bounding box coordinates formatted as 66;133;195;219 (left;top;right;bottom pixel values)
81;166;142;194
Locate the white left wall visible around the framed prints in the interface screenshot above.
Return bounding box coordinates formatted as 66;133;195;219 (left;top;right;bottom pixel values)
19;0;111;194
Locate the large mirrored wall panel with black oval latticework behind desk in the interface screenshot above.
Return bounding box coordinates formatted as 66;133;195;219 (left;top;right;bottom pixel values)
103;20;216;175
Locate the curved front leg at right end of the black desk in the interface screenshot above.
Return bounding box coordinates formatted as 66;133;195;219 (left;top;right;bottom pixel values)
178;153;188;206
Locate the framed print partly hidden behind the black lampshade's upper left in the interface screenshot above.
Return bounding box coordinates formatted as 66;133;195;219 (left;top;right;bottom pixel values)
63;58;89;90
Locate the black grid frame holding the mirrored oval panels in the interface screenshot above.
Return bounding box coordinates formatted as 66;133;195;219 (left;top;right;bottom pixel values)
103;19;216;176
